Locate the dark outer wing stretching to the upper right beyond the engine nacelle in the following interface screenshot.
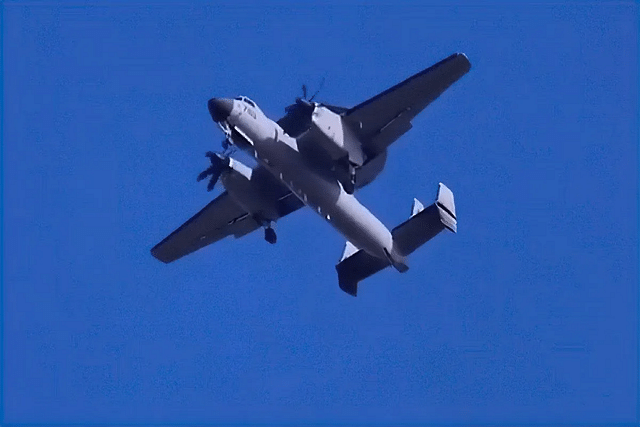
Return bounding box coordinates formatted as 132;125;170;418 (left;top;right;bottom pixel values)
344;53;471;155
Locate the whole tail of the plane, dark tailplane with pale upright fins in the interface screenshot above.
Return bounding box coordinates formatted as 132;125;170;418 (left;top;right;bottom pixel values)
336;183;458;296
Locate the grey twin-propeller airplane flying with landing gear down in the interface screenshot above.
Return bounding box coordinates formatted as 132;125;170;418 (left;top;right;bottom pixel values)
151;53;471;296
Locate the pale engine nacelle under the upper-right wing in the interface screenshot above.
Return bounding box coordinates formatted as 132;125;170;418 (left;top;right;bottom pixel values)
309;105;365;166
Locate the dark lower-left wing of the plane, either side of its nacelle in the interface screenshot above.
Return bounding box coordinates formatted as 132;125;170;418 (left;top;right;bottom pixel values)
151;191;304;263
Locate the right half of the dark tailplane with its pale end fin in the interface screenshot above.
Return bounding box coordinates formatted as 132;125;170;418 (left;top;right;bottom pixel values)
391;183;457;256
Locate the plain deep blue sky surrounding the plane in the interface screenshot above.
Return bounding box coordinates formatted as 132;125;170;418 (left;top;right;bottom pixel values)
2;1;638;424
